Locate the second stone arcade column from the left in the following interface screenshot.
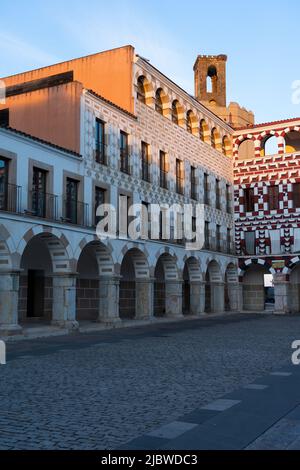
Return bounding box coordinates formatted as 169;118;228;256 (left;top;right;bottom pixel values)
51;273;79;330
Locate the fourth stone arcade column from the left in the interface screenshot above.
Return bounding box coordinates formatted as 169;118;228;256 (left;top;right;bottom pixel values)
135;279;154;320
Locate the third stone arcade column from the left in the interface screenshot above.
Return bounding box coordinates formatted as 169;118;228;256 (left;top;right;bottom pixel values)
98;276;121;323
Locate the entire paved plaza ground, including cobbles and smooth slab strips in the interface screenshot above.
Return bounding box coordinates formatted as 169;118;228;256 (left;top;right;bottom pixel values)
0;314;300;449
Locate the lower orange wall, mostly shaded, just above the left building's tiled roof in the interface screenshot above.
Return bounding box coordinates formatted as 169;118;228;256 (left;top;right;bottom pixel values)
0;82;82;153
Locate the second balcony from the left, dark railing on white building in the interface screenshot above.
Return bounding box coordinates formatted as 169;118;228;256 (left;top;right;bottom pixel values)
27;190;58;220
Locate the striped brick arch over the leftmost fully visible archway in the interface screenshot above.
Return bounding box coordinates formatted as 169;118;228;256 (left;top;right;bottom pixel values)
17;225;76;273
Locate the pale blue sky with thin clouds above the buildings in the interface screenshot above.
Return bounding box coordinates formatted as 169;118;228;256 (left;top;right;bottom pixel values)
0;0;300;122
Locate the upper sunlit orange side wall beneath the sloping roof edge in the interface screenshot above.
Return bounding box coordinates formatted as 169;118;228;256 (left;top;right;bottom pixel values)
2;46;134;113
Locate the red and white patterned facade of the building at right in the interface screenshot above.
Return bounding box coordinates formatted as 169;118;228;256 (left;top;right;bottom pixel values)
233;118;300;292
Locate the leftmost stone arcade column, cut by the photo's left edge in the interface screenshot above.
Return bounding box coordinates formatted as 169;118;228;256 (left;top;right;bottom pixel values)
0;271;22;335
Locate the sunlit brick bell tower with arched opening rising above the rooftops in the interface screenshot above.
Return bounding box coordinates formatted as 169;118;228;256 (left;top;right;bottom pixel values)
194;54;227;107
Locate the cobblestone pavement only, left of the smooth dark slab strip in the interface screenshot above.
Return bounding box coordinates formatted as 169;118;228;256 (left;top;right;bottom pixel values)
0;315;300;449
